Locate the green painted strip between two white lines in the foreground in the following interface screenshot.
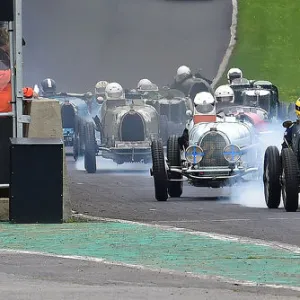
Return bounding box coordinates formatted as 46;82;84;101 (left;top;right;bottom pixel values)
0;222;300;286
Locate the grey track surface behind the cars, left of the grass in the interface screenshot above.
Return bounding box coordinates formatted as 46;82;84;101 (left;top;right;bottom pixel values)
23;0;232;92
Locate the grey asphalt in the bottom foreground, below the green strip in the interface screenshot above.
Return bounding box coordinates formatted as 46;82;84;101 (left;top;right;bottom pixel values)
0;251;299;300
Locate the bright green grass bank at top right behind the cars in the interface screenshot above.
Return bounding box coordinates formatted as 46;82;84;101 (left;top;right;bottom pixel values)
220;0;300;102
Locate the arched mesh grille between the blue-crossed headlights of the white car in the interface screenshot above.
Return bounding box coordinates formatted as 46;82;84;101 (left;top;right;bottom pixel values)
200;132;228;167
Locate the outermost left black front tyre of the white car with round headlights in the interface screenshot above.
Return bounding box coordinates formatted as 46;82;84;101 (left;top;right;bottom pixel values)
151;140;168;201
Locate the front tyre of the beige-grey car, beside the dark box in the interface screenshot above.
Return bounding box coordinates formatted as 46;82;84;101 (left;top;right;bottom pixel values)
84;122;97;173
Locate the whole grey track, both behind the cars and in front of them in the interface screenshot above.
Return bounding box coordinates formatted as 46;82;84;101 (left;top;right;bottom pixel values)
24;0;300;245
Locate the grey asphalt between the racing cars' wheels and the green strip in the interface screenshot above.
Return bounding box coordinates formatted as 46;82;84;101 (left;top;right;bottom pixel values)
67;157;300;246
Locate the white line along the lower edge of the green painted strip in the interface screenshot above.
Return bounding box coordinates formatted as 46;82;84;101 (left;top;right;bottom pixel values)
0;249;300;291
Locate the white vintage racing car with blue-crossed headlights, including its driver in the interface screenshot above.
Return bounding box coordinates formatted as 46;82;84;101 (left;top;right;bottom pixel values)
150;92;261;201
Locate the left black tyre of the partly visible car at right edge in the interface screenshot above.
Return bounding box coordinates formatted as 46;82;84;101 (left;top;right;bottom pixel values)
263;146;281;208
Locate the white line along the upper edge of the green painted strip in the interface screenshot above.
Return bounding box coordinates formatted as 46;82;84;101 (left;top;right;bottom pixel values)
74;214;300;254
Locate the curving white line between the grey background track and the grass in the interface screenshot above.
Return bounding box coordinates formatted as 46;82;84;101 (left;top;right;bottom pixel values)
212;0;238;88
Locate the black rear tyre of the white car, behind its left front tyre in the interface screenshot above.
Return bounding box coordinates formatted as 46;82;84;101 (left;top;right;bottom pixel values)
167;135;183;197
